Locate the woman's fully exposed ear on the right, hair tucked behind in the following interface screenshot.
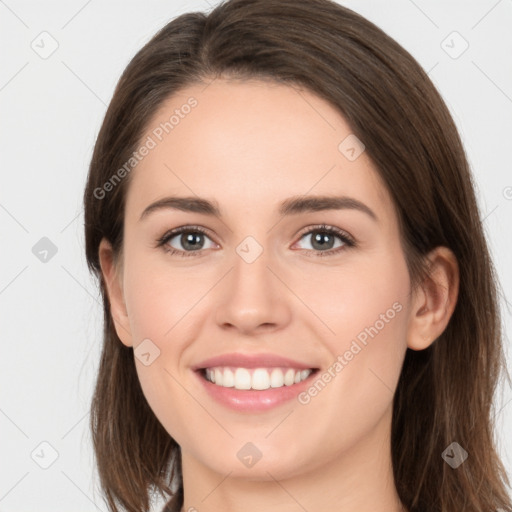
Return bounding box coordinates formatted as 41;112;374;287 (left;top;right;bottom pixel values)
407;247;459;350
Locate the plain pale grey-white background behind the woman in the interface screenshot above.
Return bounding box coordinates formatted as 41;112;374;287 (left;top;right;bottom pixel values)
0;0;512;512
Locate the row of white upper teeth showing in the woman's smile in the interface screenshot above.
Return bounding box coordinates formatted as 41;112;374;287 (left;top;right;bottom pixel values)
206;367;313;390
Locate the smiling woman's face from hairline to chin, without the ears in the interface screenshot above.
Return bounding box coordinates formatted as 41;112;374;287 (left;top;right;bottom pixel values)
102;79;411;479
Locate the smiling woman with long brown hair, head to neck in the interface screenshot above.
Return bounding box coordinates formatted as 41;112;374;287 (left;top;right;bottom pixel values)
84;0;512;512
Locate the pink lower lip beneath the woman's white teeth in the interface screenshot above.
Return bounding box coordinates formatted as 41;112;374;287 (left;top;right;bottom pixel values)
194;371;317;412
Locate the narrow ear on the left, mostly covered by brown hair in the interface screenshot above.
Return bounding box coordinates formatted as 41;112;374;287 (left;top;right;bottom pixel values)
98;238;133;347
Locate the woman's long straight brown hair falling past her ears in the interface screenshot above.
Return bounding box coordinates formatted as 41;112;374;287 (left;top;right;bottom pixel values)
84;0;512;512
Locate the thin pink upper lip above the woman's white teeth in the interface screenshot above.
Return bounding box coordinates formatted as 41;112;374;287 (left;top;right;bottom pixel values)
192;352;316;370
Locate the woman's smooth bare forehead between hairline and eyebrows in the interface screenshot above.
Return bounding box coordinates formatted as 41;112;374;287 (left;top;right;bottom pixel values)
127;79;393;223
